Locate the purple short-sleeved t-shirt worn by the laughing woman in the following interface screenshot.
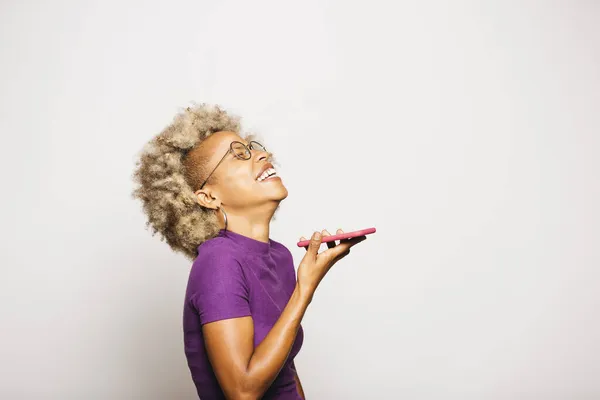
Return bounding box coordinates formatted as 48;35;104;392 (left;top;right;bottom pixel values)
183;230;304;400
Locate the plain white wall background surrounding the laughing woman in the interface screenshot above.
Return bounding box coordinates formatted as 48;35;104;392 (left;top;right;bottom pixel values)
0;0;600;400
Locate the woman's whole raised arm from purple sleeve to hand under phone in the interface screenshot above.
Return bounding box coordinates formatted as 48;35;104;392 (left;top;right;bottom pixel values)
200;234;364;400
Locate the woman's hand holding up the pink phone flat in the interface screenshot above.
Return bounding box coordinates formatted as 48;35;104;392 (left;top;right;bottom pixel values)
297;229;366;298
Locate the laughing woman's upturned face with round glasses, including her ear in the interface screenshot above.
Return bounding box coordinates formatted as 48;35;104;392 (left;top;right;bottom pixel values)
196;132;288;211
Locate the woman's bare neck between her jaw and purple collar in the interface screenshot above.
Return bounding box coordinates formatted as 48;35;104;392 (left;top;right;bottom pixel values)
219;204;277;243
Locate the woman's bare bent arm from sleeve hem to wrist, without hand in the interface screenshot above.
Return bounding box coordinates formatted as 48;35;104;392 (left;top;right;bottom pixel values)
202;285;310;399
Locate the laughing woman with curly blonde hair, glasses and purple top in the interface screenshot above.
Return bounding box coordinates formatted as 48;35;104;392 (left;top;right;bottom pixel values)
134;105;364;399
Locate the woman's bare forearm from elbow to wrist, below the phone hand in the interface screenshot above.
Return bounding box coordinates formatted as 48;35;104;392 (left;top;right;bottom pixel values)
245;285;311;398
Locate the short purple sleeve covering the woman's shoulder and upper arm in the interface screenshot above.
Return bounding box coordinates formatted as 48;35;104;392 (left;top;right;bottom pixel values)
188;246;251;325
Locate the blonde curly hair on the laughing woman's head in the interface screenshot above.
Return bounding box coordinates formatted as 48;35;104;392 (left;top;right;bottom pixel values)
132;104;240;260
